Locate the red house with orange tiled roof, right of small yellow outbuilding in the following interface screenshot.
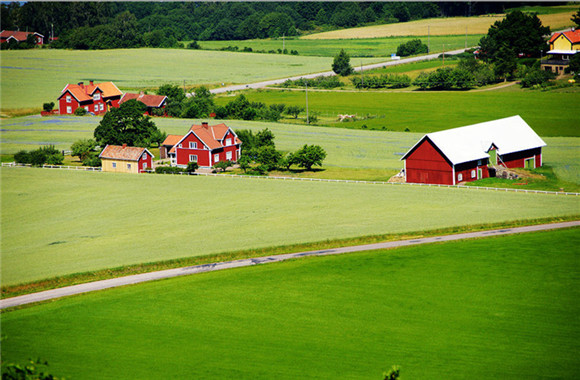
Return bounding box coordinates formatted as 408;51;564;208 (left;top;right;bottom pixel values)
160;122;242;167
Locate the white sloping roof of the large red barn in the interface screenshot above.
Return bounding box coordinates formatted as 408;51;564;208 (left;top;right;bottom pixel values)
401;115;546;165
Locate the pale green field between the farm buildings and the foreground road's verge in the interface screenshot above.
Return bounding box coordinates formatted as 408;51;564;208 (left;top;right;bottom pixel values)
1;168;579;285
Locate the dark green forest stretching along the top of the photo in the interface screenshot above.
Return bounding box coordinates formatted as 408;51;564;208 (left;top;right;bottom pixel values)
0;2;536;49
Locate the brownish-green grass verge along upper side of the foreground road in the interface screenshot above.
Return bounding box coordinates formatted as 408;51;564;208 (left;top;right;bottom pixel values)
1;215;580;302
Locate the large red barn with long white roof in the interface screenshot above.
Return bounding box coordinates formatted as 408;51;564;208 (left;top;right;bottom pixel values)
401;116;546;185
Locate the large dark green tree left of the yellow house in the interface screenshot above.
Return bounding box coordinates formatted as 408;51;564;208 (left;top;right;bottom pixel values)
479;11;550;62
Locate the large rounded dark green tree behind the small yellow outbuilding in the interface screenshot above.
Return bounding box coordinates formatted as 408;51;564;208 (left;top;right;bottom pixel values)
94;99;158;147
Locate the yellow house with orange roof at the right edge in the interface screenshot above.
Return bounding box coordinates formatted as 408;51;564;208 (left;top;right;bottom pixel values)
541;28;580;75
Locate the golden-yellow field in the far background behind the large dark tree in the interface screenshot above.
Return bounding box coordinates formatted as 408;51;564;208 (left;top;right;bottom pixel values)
302;6;578;40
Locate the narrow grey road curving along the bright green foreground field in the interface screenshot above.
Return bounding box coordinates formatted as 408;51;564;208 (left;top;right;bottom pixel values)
0;221;580;309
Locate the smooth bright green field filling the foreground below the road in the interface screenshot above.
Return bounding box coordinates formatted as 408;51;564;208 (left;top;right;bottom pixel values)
2;229;580;379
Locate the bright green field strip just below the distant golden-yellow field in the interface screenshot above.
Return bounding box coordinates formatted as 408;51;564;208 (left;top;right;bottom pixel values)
199;32;483;58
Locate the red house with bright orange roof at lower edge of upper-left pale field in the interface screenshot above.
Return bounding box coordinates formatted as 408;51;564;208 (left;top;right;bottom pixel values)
58;81;123;115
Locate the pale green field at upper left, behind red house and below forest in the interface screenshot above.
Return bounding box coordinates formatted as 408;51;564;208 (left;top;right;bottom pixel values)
0;49;386;111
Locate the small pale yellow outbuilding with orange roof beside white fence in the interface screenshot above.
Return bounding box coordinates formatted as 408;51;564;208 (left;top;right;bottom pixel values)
99;144;153;173
